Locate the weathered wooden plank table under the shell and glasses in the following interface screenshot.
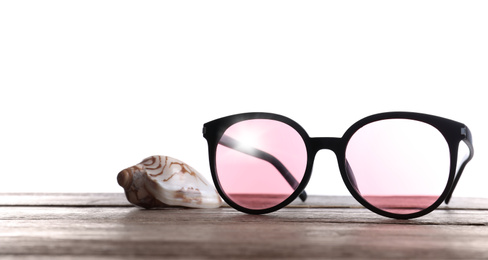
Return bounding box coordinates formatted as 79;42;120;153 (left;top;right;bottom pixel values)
0;194;488;259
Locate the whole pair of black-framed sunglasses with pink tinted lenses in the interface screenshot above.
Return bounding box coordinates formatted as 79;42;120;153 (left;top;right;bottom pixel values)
203;112;474;219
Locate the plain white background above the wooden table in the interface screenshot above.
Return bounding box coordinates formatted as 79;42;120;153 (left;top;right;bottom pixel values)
0;0;488;197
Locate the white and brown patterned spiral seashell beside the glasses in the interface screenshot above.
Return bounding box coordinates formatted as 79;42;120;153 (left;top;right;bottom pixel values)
117;155;222;208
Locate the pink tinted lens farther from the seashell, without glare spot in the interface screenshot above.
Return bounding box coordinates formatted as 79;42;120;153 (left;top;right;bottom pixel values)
346;119;450;214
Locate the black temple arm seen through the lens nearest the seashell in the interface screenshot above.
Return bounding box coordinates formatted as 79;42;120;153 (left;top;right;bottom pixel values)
219;135;307;201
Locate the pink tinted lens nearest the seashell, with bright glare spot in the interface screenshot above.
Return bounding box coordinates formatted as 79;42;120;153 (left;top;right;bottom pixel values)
216;119;307;209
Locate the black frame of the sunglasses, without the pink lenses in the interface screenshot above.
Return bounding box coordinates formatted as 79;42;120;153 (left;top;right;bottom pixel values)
203;112;474;219
